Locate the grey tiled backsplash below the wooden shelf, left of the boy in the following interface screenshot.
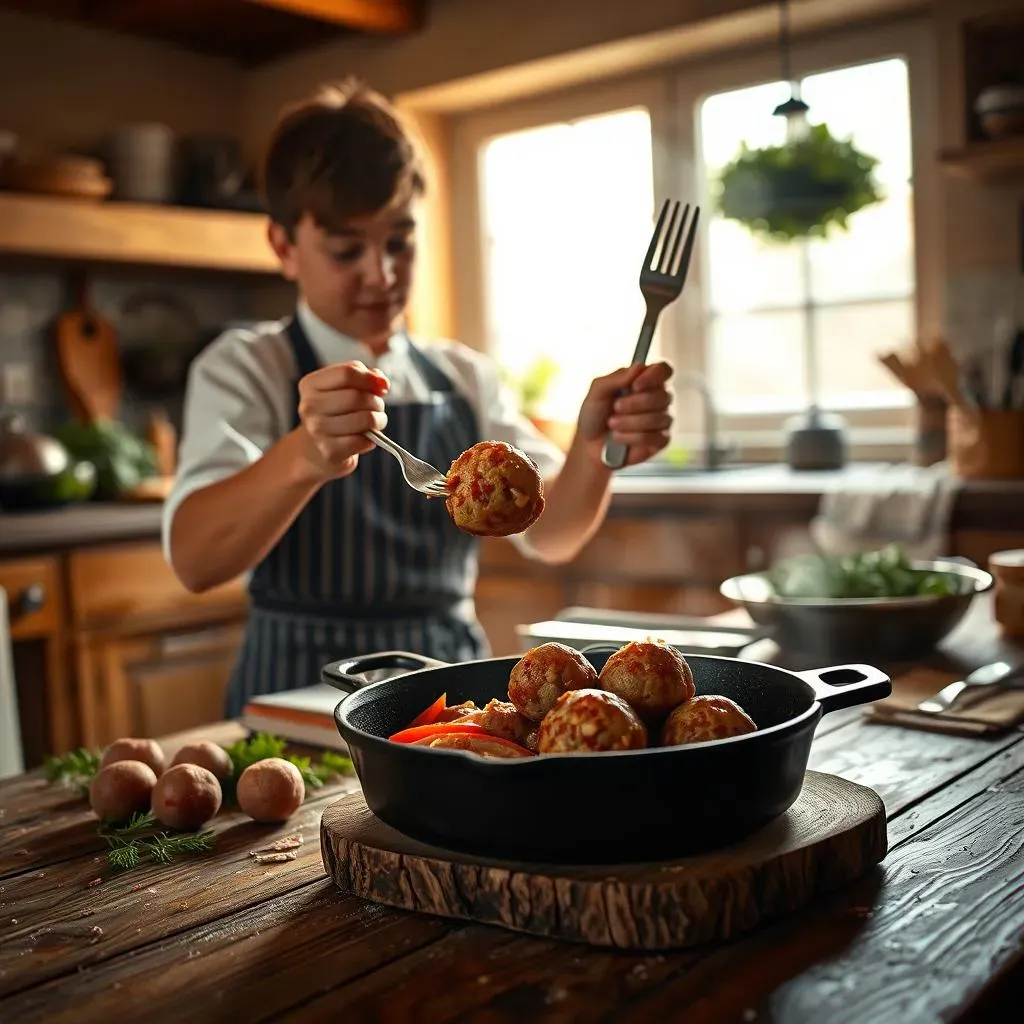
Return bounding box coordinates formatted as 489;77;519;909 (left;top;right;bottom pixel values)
0;271;248;428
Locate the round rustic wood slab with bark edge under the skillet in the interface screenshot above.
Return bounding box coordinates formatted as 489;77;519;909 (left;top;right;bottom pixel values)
321;771;888;950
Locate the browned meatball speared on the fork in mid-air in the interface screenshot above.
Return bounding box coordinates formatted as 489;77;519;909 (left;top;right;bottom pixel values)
445;441;544;537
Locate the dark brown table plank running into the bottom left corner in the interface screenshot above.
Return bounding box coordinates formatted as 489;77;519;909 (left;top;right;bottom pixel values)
0;880;457;1024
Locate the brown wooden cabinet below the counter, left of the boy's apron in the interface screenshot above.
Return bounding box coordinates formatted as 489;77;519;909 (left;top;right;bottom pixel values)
0;541;248;767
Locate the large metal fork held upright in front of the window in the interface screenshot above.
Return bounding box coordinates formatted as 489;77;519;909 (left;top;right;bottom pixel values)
601;200;700;469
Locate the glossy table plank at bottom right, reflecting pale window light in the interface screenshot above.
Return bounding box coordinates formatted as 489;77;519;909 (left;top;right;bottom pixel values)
614;768;1024;1024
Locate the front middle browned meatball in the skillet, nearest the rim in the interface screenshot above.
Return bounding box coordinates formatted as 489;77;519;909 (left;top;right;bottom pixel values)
537;689;647;754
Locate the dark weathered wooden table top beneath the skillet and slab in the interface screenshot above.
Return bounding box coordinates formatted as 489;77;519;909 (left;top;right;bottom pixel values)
0;602;1024;1024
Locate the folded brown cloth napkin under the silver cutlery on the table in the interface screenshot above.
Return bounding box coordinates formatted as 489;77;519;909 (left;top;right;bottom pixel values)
863;668;1024;736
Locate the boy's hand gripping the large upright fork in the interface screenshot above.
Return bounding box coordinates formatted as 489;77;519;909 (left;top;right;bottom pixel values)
577;362;672;466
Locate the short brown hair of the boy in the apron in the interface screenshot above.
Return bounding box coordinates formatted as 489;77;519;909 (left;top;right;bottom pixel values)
262;79;426;234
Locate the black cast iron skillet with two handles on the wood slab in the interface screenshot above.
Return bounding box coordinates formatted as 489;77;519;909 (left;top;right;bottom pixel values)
323;644;892;864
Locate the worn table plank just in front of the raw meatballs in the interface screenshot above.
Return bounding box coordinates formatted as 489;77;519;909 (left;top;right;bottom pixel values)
0;779;358;995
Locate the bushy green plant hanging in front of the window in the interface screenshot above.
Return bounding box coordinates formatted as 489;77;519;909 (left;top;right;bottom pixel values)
714;124;883;242
